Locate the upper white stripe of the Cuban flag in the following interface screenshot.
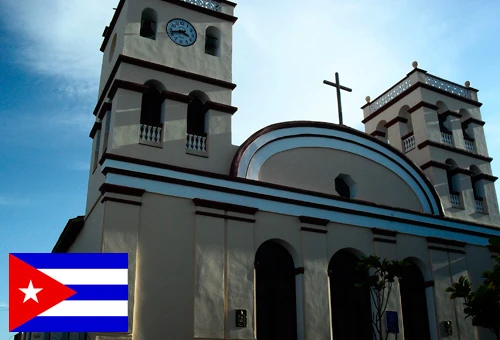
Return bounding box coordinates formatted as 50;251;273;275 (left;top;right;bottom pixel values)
39;269;128;285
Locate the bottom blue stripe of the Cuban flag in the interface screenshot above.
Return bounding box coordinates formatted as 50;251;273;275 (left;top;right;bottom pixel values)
12;316;128;333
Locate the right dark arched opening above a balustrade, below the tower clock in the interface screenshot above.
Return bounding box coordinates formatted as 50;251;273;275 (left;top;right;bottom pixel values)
187;90;210;137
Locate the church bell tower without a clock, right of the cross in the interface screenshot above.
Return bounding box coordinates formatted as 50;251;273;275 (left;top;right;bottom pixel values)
362;62;500;225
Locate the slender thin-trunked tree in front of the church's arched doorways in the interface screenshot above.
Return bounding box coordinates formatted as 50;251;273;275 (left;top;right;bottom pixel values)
356;255;408;340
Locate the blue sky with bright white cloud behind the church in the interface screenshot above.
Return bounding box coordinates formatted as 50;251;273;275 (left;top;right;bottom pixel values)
0;0;500;339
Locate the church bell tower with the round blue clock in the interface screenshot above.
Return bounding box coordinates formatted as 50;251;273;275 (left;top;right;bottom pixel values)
87;0;237;209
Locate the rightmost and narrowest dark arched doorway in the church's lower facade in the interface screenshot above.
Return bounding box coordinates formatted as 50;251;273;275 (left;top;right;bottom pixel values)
399;261;430;340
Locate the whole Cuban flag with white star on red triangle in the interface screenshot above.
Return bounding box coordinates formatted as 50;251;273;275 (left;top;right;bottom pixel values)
9;253;128;333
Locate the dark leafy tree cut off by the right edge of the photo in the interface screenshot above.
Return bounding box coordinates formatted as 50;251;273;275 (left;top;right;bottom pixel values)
446;238;500;340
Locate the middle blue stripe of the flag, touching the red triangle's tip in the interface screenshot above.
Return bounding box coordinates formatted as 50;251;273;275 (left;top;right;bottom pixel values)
67;285;128;301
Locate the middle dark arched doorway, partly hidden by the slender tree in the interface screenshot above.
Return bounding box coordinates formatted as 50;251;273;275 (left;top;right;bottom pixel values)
328;250;373;340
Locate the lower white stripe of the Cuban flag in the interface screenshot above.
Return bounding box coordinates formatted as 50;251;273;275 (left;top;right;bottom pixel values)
38;300;128;316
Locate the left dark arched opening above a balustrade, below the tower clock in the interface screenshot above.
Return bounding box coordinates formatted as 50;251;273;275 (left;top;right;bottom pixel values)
141;80;165;126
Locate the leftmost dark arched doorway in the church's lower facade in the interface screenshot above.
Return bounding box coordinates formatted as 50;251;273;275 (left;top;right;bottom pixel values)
255;241;297;340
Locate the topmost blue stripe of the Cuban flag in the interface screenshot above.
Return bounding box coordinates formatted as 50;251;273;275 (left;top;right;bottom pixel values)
12;253;128;269
